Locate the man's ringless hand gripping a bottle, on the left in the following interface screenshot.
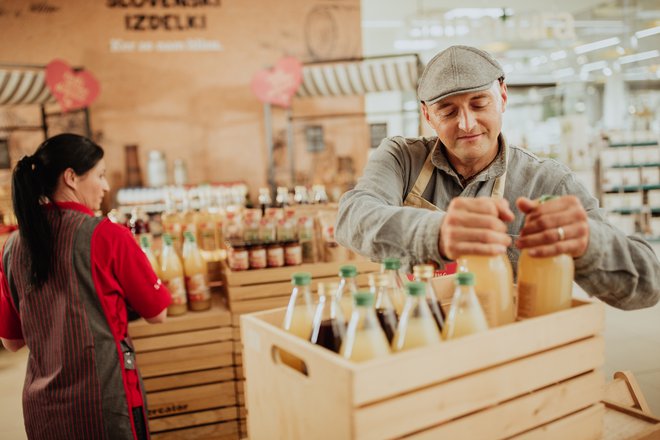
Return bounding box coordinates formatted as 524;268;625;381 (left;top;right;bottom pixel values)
438;197;514;260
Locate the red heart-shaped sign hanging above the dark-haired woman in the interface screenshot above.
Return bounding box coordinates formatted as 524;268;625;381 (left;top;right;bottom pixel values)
46;59;101;112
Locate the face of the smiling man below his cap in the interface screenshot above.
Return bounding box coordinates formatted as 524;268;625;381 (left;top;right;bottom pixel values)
422;82;507;165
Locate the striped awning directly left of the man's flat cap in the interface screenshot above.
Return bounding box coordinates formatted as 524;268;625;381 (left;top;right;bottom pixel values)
296;54;422;98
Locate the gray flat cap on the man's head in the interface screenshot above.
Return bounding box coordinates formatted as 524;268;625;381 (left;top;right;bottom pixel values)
417;46;504;105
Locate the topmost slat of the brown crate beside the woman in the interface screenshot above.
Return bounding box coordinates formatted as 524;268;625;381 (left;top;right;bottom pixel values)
128;295;231;342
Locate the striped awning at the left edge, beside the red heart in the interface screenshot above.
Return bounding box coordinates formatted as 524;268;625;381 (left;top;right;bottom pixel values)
0;66;55;105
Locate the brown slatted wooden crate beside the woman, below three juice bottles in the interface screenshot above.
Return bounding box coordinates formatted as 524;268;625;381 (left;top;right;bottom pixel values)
129;295;239;440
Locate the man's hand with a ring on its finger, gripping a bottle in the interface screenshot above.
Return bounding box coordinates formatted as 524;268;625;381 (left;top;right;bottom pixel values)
516;196;589;258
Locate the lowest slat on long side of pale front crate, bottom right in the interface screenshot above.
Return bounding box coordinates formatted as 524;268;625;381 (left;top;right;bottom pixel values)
511;403;605;440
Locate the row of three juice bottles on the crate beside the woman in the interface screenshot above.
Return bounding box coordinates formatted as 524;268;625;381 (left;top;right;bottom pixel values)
140;231;211;316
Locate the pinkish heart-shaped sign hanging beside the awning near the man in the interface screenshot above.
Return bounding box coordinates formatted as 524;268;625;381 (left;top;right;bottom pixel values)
251;57;302;108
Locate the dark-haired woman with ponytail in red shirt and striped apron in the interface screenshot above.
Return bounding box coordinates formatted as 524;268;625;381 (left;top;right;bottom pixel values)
0;134;171;439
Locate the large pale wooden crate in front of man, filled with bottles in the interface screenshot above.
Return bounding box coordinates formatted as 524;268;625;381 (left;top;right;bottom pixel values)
241;301;604;440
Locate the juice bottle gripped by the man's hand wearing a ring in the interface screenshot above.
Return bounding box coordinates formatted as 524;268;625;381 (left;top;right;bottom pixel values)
518;196;575;318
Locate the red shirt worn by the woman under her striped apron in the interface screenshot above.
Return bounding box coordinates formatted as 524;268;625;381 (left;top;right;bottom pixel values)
0;202;172;407
